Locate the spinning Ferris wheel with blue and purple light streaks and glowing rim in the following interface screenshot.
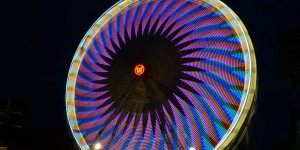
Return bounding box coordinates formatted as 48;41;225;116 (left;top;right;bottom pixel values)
66;0;256;149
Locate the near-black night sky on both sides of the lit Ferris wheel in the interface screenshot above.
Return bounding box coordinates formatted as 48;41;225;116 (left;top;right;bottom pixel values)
0;0;300;149
